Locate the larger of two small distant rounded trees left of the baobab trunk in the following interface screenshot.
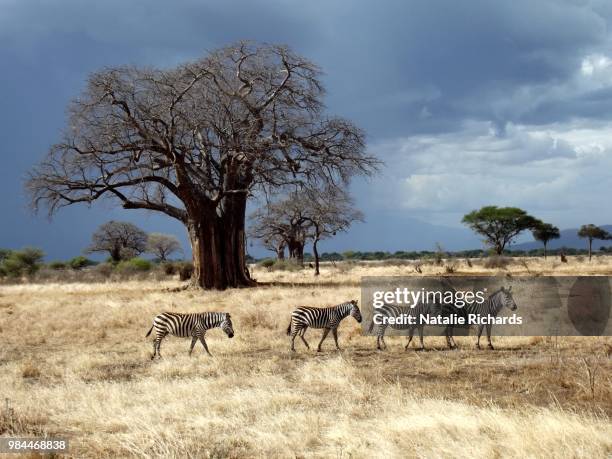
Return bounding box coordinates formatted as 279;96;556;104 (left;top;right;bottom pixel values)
85;220;147;262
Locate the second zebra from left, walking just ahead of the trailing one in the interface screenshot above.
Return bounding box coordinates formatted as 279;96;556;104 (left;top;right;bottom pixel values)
287;300;361;352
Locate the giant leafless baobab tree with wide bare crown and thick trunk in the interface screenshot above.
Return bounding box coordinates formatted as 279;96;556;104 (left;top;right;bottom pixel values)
27;43;377;289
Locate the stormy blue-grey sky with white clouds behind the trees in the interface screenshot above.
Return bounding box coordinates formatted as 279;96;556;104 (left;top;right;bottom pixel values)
0;0;612;259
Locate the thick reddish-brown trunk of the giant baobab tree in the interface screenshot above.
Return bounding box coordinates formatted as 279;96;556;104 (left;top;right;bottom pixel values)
187;198;256;290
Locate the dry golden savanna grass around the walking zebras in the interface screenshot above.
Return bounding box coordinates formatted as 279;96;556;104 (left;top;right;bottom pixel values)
0;258;612;458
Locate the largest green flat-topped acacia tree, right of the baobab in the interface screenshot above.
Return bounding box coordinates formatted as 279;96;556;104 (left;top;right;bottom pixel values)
462;206;541;255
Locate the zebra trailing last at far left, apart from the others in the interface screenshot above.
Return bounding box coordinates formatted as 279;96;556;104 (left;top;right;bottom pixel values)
146;312;234;360
